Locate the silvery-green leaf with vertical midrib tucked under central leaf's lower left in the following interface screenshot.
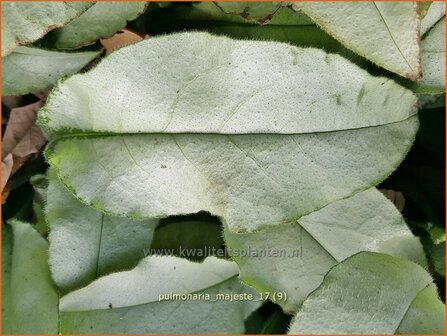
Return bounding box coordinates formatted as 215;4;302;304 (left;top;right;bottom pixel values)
45;171;158;291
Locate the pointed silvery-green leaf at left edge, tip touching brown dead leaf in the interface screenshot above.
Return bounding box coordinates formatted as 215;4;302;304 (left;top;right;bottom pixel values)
2;47;101;95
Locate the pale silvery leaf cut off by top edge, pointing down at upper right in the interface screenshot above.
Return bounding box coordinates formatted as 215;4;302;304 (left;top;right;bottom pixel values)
291;1;421;80
